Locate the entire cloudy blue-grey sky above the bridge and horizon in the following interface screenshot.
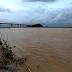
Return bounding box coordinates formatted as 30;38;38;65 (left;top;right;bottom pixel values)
0;0;72;26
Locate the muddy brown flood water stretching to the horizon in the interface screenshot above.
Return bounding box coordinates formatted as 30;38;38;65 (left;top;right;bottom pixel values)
0;28;72;72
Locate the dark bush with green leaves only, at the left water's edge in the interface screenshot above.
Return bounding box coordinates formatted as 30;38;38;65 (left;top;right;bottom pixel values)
0;32;27;72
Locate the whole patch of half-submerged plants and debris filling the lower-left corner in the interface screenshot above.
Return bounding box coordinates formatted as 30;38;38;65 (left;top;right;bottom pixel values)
0;33;27;72
